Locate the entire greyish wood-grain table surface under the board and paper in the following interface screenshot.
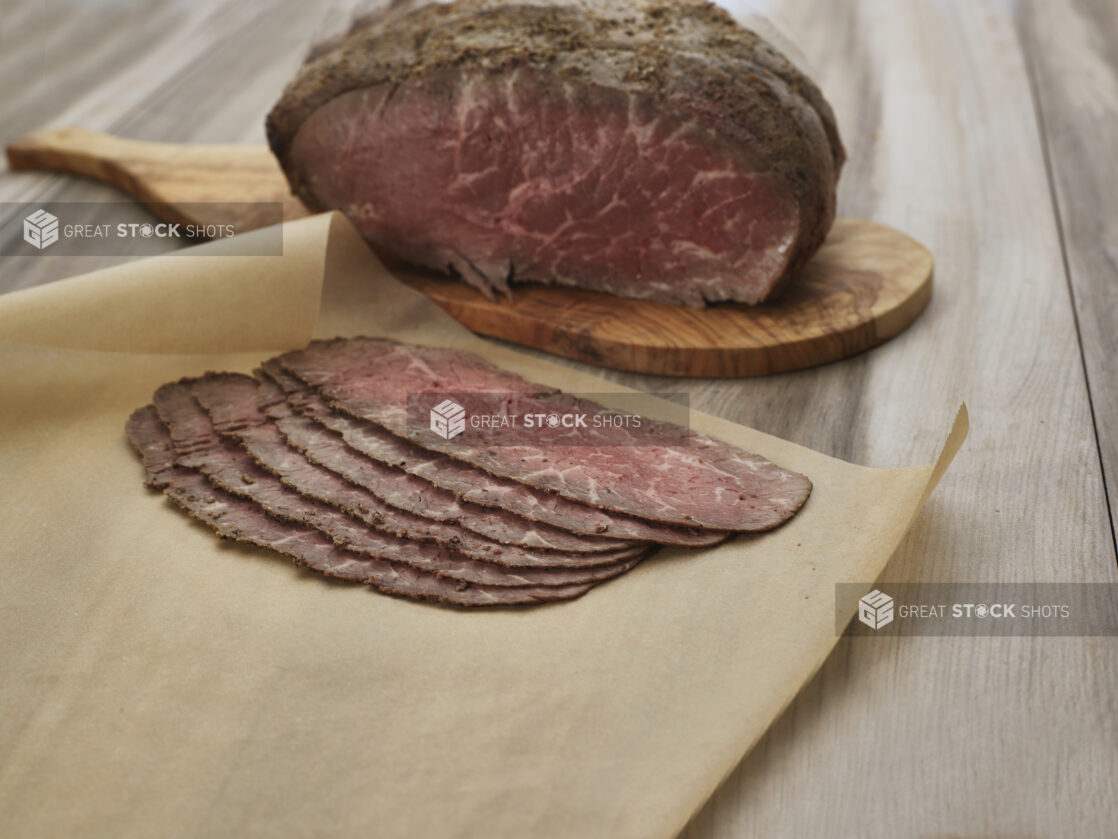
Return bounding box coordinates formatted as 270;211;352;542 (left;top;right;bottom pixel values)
0;0;1118;839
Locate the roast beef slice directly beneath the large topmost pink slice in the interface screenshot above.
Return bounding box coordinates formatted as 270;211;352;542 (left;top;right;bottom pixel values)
260;360;727;547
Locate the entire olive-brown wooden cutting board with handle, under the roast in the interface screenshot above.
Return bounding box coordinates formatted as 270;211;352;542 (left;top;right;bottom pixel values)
7;128;932;376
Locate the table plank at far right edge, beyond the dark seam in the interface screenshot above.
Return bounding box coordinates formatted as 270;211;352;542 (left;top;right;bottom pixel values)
1021;0;1118;559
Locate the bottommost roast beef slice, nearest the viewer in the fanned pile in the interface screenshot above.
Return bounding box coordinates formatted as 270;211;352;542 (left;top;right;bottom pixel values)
127;405;593;606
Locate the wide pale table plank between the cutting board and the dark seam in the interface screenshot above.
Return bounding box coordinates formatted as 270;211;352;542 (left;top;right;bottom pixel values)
683;0;1118;839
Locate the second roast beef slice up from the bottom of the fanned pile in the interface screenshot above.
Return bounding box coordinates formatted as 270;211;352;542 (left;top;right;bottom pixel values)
154;379;638;587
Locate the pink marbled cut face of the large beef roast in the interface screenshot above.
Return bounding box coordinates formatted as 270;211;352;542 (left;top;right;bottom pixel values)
292;68;799;305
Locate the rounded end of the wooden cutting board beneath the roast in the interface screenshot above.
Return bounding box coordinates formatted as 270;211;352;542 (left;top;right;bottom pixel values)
392;218;932;377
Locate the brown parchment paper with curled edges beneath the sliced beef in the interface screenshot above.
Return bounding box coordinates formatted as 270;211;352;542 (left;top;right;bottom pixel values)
0;215;966;839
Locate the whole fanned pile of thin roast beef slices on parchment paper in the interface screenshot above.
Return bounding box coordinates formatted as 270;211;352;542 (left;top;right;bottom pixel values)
127;338;811;606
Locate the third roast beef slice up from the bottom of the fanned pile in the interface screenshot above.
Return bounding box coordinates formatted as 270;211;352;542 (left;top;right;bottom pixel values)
191;374;647;582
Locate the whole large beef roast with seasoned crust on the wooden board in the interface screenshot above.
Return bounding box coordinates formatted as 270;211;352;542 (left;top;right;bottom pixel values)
267;0;844;307
